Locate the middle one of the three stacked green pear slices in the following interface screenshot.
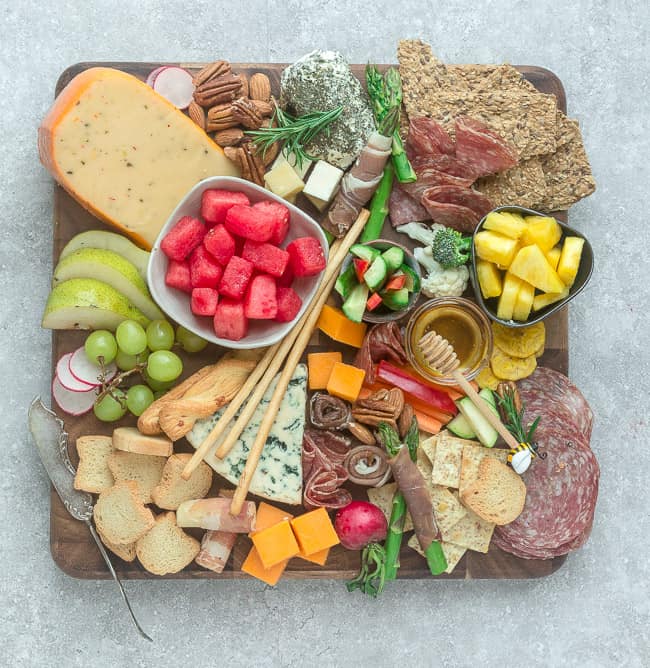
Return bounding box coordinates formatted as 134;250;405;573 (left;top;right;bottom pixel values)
54;248;165;320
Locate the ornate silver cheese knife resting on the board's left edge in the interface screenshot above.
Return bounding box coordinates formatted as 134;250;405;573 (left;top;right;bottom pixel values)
29;397;153;642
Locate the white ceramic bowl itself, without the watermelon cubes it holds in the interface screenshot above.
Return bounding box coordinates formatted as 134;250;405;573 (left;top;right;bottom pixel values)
147;176;328;349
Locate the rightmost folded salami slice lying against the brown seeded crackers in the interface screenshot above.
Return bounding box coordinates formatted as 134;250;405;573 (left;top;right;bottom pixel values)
455;116;519;177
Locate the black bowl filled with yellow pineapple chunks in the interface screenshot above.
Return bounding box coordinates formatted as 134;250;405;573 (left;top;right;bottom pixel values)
470;206;594;327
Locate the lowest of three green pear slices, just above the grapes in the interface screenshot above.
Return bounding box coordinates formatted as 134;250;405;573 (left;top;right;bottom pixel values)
41;278;149;331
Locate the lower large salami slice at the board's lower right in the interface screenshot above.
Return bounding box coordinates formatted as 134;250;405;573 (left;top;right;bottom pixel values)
495;423;600;559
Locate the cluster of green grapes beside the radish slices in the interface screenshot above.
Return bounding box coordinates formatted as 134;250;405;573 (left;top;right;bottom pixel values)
84;320;207;422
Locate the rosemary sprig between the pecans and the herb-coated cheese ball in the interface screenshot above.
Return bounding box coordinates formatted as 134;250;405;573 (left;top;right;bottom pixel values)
245;103;343;168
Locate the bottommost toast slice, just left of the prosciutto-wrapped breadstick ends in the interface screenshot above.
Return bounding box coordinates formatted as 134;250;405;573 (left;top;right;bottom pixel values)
136;512;201;575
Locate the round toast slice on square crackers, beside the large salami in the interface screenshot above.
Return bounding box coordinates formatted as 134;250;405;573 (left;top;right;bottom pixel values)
460;457;526;525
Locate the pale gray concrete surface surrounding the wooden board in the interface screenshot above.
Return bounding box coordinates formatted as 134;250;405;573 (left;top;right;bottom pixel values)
0;0;650;667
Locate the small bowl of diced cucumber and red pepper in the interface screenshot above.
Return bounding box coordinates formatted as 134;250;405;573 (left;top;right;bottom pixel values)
334;239;421;323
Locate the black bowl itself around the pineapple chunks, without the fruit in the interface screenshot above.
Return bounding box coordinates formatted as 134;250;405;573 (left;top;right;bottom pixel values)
470;206;594;327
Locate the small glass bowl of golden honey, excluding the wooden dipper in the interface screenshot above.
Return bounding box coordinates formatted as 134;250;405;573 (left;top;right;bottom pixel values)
406;297;492;384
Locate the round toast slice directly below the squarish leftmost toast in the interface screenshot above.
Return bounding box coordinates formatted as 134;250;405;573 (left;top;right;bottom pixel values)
93;480;156;545
